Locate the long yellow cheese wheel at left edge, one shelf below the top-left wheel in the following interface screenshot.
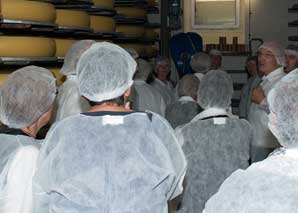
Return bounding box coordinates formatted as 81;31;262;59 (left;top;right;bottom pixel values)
0;36;55;57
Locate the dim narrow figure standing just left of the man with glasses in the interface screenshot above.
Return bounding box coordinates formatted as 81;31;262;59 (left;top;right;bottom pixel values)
239;56;261;119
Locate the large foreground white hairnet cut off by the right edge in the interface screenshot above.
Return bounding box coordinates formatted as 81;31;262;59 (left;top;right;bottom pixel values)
267;71;298;147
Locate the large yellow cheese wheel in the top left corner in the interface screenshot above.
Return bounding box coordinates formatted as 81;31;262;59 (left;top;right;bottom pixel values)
1;0;56;23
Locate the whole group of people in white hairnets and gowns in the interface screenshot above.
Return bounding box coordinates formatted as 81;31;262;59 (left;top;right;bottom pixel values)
0;40;298;213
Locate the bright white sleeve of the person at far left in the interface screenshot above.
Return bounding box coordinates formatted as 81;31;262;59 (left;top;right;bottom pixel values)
1;146;39;213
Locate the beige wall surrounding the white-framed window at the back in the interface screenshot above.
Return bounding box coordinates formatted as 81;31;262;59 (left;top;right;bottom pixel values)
184;0;247;44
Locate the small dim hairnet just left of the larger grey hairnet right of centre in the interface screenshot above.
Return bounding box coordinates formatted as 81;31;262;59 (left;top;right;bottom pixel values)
178;75;200;98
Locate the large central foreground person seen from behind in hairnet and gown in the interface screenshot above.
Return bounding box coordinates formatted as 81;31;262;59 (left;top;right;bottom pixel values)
34;42;186;213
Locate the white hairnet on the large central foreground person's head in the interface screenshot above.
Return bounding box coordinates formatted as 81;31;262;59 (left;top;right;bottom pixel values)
77;42;137;102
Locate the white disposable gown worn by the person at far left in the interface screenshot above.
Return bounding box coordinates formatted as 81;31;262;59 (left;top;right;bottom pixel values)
0;134;39;213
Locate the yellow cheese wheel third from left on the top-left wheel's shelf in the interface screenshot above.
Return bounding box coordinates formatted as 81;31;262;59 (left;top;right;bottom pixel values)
90;16;115;32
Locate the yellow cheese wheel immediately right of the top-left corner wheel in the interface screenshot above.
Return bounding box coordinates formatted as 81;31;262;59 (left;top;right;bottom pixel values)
56;9;90;28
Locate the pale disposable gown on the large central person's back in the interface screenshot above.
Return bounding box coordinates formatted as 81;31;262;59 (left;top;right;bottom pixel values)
34;112;186;213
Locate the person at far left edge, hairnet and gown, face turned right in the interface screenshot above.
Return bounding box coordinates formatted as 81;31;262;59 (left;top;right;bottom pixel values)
0;66;56;213
